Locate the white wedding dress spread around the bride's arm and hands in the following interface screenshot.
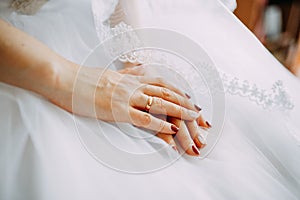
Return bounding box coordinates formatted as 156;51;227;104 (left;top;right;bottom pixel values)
0;0;300;200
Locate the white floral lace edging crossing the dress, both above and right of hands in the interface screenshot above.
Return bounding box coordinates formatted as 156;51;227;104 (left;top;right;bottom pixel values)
91;8;294;111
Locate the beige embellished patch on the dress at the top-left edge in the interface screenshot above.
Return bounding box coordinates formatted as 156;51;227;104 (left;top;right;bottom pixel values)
10;0;48;15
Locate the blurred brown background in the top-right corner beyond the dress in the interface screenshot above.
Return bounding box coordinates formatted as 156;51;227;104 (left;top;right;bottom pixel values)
234;0;300;77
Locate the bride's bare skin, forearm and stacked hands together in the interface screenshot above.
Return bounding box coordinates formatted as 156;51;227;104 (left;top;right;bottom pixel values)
0;19;210;155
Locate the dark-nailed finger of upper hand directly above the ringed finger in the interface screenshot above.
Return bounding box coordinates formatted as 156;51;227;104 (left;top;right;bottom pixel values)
143;85;201;112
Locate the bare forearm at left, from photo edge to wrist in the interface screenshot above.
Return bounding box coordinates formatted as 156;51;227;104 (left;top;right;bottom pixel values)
0;19;76;99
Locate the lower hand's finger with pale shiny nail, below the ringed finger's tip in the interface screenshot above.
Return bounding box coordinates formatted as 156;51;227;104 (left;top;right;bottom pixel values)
186;121;207;148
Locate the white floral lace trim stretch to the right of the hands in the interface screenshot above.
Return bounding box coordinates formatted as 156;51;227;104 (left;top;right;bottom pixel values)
191;63;294;111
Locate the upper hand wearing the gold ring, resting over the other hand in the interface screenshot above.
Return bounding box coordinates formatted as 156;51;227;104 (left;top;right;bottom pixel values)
52;63;199;134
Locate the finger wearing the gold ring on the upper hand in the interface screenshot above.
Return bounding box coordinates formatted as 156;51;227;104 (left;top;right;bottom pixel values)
131;94;200;120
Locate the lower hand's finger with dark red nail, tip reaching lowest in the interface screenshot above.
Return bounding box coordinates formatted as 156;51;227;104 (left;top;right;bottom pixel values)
169;118;200;156
